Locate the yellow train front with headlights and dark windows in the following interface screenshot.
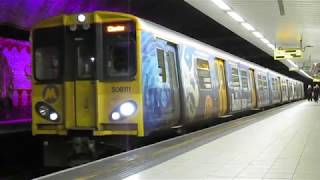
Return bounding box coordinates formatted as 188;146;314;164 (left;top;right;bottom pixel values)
32;12;144;165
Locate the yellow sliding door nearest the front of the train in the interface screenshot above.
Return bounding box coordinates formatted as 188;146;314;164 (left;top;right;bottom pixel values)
215;59;228;116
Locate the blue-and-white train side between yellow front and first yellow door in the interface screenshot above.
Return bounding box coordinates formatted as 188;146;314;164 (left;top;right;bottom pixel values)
142;32;219;134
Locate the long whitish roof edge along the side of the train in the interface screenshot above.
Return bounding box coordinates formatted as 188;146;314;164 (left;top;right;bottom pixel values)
138;18;300;82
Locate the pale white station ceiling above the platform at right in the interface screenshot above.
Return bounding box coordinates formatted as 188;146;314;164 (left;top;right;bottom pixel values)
185;0;320;81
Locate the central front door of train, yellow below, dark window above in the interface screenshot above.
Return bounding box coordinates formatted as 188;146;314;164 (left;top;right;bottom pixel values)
69;31;96;129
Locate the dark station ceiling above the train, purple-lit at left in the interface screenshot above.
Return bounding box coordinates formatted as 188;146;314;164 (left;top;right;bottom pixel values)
0;0;310;83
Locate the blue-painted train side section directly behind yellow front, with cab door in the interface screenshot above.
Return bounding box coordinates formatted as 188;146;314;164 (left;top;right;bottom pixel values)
141;32;180;134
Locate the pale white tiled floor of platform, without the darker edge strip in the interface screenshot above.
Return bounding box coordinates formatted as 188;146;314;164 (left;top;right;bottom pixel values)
125;101;320;180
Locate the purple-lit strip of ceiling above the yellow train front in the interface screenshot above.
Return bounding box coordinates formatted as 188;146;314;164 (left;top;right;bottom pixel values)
0;0;129;29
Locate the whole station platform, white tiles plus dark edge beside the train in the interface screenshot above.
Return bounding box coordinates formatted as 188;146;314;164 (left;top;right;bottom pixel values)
38;100;320;180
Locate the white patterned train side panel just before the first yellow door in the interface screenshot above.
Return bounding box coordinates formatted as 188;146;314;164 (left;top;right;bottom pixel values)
178;45;219;124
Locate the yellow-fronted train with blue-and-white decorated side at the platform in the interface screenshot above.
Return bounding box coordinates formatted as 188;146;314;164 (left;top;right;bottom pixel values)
31;11;304;166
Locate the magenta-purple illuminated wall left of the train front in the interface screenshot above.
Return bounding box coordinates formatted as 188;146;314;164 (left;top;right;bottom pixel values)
0;38;31;120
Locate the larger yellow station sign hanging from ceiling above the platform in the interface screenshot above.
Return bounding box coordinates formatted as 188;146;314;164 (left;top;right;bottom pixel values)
273;48;303;60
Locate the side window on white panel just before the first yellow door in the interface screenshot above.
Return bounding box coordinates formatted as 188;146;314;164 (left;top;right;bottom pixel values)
197;58;212;89
